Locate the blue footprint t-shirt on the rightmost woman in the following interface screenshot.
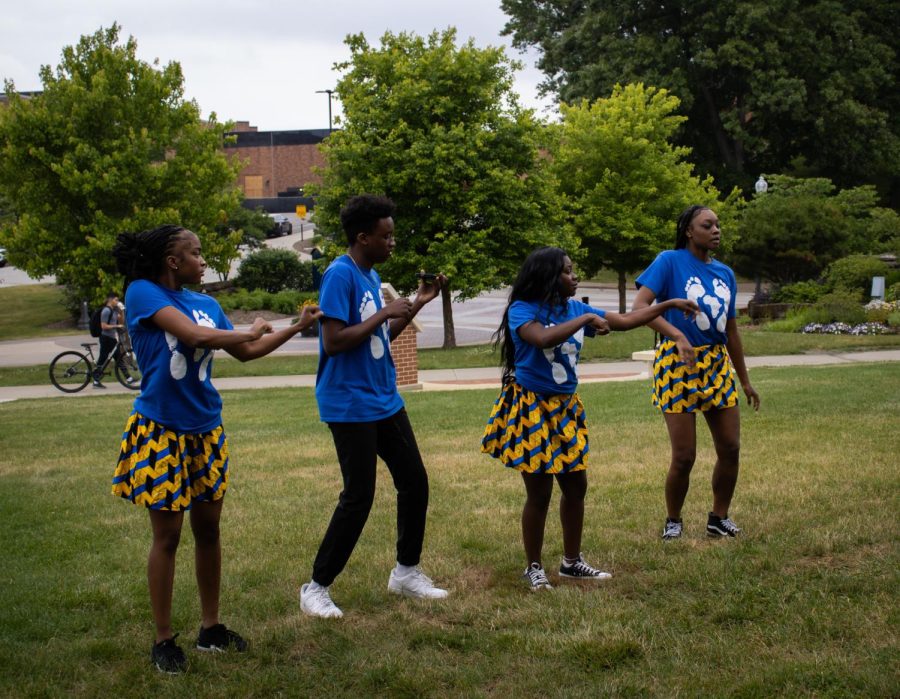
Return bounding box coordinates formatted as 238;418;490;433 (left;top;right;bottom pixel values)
635;248;737;347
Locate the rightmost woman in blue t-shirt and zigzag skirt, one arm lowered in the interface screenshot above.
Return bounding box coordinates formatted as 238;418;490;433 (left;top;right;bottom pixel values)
633;206;759;541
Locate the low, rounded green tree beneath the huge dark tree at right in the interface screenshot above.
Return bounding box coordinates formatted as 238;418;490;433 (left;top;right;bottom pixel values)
732;175;896;285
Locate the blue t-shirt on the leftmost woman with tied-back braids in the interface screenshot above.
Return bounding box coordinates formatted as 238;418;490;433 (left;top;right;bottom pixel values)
125;279;234;433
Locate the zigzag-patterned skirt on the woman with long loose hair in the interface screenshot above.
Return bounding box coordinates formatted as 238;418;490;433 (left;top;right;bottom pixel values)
481;382;590;474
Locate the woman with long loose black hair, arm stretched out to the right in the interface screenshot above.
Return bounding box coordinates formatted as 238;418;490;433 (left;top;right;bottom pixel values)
481;247;697;590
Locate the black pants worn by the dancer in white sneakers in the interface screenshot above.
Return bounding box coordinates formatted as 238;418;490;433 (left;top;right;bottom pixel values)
313;410;428;586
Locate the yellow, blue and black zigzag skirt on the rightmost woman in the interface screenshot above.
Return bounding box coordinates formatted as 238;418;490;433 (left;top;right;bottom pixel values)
653;339;738;413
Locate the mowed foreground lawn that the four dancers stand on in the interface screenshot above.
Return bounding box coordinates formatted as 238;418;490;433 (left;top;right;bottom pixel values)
0;364;900;697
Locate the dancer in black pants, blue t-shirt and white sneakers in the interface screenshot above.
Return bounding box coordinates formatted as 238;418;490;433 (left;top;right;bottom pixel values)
300;194;447;618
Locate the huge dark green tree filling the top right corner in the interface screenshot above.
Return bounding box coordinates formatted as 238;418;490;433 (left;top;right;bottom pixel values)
501;0;900;203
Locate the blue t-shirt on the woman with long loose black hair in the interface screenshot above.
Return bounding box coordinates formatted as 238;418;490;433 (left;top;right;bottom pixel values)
509;299;606;395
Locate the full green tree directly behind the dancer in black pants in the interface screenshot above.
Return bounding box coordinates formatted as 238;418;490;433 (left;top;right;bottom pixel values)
315;29;559;347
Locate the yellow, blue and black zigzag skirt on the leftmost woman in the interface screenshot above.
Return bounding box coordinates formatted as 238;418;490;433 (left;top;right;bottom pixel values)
112;412;228;512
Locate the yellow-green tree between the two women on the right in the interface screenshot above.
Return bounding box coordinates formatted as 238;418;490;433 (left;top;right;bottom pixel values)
551;85;737;312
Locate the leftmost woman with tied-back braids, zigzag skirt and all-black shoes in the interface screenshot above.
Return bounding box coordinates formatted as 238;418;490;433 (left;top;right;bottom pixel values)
112;225;321;673
